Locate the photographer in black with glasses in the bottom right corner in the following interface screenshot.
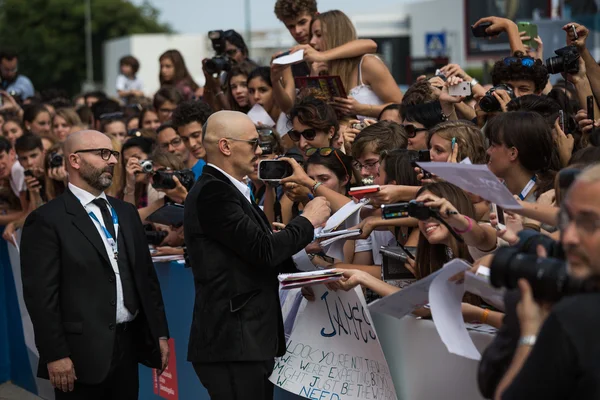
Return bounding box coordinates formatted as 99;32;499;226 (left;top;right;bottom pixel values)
495;166;600;399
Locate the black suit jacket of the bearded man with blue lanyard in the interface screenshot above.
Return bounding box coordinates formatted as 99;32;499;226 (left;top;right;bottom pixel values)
21;189;169;384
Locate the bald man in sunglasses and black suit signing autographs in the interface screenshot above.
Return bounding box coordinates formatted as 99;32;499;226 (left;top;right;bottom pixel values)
184;111;330;400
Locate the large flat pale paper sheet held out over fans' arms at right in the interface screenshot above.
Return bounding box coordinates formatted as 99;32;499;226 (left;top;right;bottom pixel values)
417;162;523;210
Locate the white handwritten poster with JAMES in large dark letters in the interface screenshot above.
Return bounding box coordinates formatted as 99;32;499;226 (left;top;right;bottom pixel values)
269;285;397;400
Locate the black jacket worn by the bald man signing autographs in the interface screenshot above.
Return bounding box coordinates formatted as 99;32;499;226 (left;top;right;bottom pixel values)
184;166;314;362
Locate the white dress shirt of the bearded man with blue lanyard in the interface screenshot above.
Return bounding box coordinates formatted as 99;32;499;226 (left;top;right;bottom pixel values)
69;183;135;324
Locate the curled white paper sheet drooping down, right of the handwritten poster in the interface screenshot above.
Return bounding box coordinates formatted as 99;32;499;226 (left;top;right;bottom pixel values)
429;259;481;360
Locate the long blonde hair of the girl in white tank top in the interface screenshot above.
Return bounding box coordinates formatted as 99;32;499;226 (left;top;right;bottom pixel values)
311;10;361;91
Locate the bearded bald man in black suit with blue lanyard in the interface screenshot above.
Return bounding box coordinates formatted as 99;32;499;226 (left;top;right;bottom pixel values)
21;131;169;400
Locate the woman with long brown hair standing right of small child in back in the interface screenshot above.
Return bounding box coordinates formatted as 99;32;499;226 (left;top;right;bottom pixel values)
158;50;200;100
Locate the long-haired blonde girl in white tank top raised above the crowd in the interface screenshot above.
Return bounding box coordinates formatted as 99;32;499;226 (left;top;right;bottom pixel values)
310;10;402;118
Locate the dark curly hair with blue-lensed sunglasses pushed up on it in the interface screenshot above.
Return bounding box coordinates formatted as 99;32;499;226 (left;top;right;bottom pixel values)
492;51;548;93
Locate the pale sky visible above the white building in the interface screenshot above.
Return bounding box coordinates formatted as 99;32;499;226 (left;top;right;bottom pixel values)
132;0;403;33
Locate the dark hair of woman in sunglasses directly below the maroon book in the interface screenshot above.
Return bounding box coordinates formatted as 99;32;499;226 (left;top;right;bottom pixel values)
287;96;340;133
